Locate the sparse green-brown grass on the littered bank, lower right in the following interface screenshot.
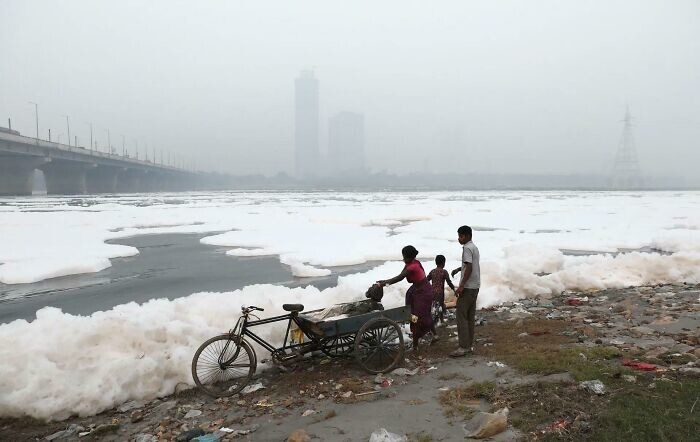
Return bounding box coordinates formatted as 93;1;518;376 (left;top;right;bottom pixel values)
440;320;700;441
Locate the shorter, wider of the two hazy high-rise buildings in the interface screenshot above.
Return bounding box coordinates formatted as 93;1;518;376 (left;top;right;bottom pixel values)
328;112;365;176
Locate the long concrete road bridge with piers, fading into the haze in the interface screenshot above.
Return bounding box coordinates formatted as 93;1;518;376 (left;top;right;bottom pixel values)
0;130;205;195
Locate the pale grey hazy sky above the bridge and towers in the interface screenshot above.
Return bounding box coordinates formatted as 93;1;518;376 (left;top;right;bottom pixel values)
0;0;700;175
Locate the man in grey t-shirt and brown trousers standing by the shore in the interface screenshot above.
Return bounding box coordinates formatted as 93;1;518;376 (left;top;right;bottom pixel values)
450;226;481;357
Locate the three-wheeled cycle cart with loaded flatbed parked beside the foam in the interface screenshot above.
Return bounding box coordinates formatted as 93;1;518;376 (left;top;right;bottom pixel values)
192;300;411;397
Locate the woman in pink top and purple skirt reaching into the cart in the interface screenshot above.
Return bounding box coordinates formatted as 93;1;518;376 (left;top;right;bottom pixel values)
377;246;437;351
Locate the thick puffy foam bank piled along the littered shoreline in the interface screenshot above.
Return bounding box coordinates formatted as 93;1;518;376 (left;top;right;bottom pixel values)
0;253;700;420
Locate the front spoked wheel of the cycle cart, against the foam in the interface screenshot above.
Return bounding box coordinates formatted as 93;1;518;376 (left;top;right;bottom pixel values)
192;334;257;397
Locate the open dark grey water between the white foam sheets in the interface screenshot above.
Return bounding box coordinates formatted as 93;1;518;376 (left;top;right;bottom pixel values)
0;233;376;323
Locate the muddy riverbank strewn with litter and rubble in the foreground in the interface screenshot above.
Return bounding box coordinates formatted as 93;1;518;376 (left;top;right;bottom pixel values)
0;284;700;442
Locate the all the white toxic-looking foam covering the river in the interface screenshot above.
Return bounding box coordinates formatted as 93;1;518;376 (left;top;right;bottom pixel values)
0;192;700;419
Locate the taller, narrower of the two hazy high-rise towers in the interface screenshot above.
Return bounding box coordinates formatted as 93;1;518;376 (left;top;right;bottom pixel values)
294;70;320;178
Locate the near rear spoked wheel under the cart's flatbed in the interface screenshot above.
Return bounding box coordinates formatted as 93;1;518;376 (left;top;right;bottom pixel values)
355;318;404;374
